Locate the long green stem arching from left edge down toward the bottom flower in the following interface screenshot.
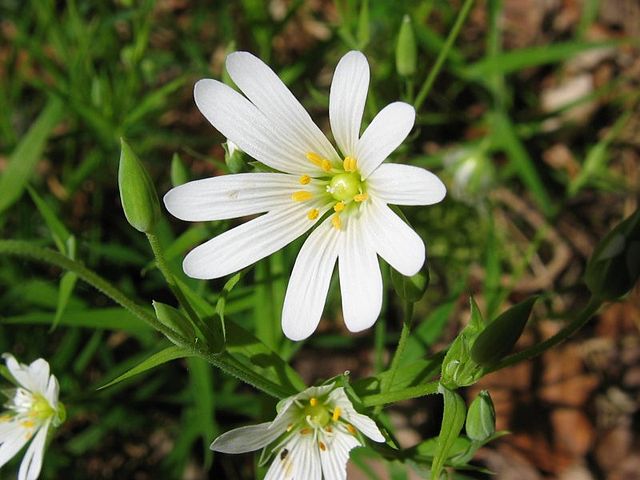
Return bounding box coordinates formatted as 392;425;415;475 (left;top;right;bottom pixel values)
0;240;292;398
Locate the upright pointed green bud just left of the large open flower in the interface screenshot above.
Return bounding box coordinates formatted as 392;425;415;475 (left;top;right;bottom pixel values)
118;139;160;233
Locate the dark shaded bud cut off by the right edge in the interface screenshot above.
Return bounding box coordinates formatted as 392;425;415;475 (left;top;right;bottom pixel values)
585;210;640;300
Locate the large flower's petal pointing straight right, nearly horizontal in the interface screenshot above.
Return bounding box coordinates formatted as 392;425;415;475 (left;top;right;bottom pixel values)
367;163;447;205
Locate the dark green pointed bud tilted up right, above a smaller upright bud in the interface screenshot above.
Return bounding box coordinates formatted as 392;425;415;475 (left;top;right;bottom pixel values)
471;296;538;367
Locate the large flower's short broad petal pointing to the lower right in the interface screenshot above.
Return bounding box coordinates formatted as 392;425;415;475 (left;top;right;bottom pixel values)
363;198;425;277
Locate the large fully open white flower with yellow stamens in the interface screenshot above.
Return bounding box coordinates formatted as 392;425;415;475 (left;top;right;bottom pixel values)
164;51;445;340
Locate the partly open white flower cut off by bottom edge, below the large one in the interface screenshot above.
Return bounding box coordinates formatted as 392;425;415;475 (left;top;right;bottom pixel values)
211;384;384;480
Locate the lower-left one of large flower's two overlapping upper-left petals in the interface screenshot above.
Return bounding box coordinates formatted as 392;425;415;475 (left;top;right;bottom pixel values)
194;79;314;175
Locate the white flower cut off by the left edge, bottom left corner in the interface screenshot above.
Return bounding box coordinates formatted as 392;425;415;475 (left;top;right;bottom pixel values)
0;353;65;480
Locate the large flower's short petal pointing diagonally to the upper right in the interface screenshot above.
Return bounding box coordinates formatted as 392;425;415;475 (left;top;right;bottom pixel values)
355;102;416;178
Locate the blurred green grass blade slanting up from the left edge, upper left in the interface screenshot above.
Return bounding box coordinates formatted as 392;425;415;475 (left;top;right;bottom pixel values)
0;99;64;213
